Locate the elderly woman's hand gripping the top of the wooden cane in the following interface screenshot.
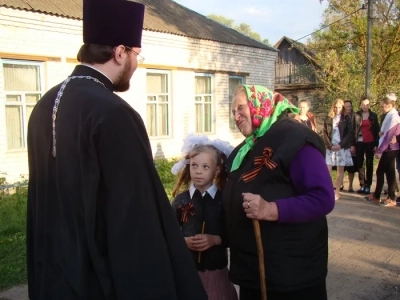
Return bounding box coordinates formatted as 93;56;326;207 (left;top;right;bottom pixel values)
242;193;279;221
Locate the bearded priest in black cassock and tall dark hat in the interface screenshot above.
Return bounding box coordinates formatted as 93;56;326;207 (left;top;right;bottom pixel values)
27;0;207;300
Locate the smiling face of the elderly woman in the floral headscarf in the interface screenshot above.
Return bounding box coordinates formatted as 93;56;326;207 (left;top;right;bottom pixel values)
232;93;254;137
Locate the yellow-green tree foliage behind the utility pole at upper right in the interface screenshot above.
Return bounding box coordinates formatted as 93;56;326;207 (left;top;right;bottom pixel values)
308;0;400;108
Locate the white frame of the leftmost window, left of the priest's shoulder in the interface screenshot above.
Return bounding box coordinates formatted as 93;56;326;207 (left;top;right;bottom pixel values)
0;59;45;152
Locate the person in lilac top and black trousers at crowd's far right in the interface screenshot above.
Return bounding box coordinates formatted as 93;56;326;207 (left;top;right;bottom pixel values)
365;94;400;207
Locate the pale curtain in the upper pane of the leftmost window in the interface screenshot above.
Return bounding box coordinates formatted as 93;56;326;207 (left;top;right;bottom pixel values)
3;63;40;91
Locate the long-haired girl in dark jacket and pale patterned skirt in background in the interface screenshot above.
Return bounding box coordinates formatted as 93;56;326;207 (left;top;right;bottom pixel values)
323;99;354;200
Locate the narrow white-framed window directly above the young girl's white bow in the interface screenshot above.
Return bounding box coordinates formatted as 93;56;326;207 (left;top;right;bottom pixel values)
194;74;214;133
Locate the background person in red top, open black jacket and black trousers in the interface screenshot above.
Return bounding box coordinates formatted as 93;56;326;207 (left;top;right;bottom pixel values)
356;97;379;194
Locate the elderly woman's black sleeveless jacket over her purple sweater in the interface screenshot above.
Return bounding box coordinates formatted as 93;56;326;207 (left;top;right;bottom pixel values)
223;117;328;292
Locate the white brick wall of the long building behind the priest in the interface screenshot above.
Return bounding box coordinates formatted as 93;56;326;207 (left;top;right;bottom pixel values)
0;7;276;182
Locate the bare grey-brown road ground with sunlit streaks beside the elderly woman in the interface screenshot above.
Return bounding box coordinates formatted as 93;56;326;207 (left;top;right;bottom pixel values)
0;192;400;300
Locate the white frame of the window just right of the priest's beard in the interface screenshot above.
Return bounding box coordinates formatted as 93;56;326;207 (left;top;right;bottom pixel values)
145;69;172;139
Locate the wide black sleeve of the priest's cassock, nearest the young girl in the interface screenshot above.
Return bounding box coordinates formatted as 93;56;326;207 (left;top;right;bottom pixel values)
93;103;207;300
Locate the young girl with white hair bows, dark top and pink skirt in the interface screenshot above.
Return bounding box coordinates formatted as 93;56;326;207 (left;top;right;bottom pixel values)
172;137;237;300
